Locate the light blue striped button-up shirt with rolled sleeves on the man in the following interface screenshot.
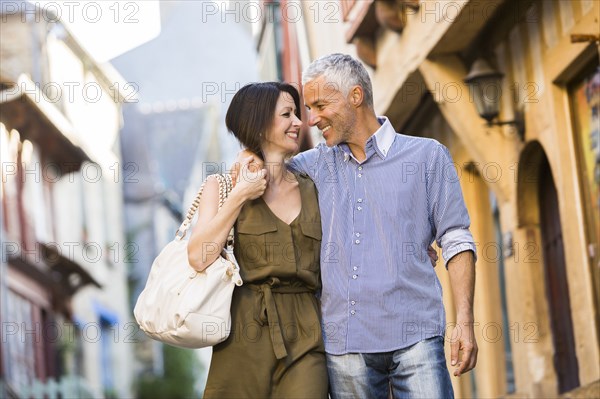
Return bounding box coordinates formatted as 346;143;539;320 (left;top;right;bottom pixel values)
290;118;475;354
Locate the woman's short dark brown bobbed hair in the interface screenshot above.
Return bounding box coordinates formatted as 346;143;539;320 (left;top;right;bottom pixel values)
225;82;301;159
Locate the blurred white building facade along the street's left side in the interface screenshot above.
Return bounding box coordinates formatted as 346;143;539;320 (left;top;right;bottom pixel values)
0;2;134;397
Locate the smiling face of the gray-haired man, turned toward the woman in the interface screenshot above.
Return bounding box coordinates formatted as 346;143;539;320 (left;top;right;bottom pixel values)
303;76;357;147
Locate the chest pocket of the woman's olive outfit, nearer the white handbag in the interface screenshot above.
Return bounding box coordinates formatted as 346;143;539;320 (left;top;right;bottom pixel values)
234;223;280;268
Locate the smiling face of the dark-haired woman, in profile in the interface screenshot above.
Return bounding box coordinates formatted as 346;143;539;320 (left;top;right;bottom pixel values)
262;92;302;156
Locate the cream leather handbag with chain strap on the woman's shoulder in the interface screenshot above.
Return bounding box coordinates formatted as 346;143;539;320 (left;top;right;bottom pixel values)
133;175;242;348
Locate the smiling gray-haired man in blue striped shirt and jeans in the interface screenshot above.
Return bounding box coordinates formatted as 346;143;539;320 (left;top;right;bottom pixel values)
237;54;477;398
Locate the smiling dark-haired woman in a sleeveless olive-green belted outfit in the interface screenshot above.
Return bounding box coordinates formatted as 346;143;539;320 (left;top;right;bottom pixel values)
188;82;327;398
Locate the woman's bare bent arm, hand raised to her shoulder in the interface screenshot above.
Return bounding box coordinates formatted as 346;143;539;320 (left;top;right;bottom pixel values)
188;163;267;271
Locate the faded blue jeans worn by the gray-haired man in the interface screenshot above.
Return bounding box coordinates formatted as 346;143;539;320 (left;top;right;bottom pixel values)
327;337;454;399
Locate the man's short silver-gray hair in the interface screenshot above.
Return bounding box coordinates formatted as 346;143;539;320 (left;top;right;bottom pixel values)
302;53;373;108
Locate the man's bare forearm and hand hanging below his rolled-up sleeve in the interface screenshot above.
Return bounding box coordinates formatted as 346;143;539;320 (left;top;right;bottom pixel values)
448;251;478;377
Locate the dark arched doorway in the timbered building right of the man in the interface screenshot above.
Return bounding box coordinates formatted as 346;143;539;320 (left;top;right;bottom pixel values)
518;142;579;393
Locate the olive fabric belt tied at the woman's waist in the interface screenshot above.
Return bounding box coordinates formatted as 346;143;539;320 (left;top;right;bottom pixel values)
247;277;312;359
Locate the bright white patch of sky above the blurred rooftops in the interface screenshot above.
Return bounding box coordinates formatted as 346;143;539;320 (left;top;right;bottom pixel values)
30;0;160;62
